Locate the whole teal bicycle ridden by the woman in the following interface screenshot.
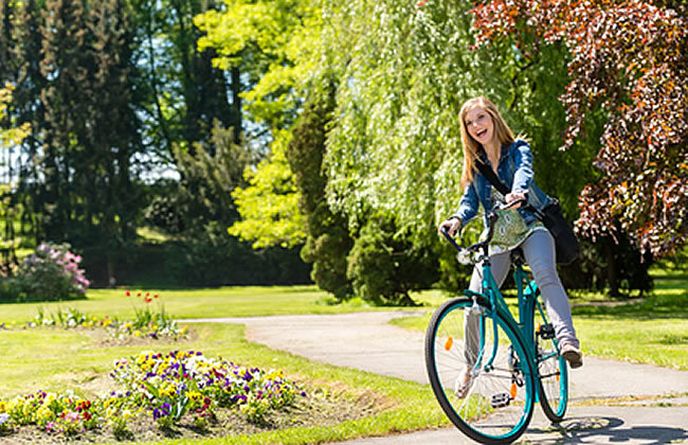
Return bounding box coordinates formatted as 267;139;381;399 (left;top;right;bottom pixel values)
425;204;568;444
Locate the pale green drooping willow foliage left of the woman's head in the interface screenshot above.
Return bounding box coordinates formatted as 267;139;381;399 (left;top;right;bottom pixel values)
324;1;490;246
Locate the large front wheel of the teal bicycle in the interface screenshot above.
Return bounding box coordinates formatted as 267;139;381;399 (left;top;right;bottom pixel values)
425;298;535;444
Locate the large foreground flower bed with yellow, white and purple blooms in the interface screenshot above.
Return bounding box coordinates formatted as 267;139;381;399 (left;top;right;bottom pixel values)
0;351;306;439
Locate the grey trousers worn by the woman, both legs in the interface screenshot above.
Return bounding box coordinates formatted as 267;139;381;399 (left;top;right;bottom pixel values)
465;230;580;364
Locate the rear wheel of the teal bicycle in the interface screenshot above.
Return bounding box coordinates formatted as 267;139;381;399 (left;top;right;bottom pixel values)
533;289;569;423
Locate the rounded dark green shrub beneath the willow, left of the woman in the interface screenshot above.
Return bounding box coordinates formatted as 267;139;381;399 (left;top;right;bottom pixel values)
347;217;437;306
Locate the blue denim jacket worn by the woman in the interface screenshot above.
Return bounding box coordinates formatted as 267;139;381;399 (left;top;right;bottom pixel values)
454;139;551;227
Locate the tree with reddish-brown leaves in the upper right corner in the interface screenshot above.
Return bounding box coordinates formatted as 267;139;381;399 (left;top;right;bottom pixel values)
473;0;688;257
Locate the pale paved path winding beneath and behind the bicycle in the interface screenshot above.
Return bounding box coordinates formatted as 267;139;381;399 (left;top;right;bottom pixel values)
184;311;688;445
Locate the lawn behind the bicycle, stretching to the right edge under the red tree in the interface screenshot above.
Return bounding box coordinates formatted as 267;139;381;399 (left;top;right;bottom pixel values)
392;272;688;370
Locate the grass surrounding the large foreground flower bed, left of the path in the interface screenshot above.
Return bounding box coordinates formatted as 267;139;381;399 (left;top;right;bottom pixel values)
0;324;448;444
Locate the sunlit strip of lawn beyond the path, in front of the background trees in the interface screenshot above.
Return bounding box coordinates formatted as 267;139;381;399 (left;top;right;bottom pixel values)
0;286;412;323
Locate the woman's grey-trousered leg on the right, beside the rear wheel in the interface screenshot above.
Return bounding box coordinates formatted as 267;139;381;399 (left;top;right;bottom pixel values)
521;230;580;349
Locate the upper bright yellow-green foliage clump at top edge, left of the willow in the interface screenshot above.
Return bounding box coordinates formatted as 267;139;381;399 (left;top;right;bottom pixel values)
194;0;322;128
